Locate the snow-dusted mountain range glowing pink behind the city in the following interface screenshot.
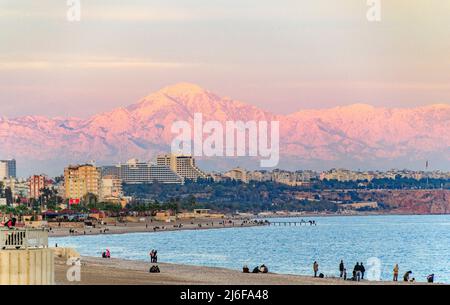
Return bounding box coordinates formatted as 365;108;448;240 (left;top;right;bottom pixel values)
0;83;450;175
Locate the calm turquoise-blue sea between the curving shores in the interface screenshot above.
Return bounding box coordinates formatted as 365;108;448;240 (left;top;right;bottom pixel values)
49;215;450;283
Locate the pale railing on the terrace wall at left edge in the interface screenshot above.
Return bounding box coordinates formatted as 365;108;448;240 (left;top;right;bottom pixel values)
0;228;48;250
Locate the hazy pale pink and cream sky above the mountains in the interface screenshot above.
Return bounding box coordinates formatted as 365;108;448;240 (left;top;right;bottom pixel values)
0;0;450;117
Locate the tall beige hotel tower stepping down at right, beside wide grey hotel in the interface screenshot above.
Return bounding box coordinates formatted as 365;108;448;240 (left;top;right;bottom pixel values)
156;154;208;181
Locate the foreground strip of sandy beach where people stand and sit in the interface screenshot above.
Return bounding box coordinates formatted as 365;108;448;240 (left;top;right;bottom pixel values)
55;257;427;285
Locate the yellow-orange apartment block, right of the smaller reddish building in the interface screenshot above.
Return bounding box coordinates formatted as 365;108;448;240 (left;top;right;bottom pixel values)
64;164;101;199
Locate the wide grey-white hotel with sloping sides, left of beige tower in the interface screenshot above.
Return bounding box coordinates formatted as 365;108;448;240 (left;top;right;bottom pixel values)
102;159;184;184
